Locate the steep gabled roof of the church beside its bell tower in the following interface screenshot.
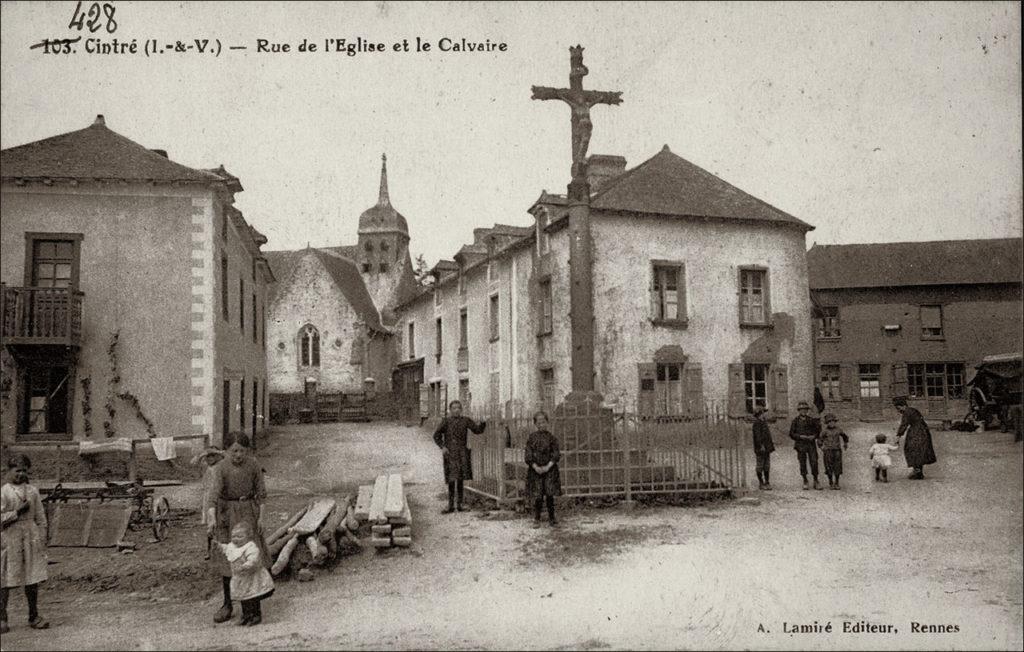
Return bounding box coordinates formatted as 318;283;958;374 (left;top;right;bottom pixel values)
264;247;388;333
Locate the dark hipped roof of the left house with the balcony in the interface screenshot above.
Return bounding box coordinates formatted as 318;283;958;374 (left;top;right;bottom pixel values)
0;116;224;183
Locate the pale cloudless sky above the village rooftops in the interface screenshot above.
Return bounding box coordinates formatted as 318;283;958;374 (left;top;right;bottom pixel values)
0;1;1024;264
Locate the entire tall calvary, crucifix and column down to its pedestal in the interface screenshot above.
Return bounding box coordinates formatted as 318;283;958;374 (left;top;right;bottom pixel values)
531;45;623;397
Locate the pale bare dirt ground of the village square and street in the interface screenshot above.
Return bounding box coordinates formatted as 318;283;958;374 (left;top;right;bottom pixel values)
2;417;1022;650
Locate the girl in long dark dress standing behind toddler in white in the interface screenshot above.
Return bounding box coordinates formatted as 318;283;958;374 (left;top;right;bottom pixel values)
207;434;270;622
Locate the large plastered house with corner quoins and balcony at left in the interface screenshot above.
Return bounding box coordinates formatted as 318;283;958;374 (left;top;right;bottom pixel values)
0;116;272;443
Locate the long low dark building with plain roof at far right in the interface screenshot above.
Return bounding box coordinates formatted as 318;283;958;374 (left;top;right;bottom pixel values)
807;238;1022;420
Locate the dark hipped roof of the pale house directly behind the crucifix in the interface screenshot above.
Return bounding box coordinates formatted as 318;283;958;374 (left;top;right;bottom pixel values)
589;145;814;230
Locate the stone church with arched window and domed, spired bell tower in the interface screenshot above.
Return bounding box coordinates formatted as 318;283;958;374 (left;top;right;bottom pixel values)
266;154;416;406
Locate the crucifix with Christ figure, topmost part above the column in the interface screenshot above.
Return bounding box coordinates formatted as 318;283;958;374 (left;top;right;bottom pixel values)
530;45;623;200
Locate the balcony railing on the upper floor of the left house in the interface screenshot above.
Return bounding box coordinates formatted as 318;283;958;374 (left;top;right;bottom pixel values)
2;286;84;346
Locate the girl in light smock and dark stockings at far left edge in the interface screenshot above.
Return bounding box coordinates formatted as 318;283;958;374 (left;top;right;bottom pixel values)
0;454;50;634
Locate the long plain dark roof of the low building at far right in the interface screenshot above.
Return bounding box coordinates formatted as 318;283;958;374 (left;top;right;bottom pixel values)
807;237;1021;290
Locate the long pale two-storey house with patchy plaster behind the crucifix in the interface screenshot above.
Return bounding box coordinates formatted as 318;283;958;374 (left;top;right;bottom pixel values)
397;147;813;418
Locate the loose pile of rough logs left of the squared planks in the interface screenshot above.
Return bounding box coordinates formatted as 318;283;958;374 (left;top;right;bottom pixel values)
266;495;361;578
